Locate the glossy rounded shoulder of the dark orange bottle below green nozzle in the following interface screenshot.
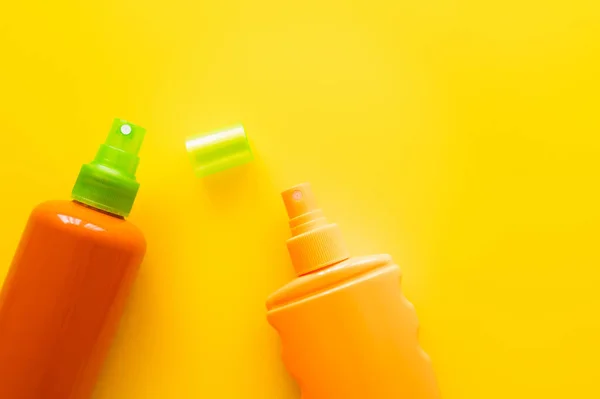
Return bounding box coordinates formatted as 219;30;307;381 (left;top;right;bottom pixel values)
29;200;146;252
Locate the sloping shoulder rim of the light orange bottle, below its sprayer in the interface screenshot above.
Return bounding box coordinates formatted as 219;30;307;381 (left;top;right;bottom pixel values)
267;254;399;310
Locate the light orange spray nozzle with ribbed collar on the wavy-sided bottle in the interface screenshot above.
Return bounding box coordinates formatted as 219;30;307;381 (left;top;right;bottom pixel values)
281;183;350;276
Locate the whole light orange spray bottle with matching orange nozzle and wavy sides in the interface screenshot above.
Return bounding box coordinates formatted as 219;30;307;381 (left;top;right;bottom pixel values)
267;184;440;399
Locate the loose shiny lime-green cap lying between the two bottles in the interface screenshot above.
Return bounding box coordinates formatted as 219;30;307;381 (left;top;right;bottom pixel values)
185;125;253;177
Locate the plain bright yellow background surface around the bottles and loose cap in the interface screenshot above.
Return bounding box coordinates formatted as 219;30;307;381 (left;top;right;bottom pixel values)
0;0;600;399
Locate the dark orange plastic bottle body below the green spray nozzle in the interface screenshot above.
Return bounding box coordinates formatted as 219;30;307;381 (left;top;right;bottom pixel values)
0;201;146;399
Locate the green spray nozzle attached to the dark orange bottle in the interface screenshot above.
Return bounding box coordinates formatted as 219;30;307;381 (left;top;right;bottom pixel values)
72;119;146;216
